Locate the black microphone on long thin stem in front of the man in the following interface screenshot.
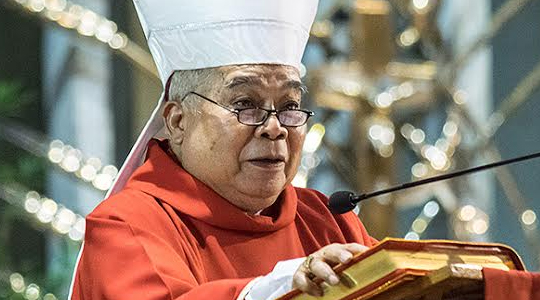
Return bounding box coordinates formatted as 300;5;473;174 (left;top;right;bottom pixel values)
328;152;540;214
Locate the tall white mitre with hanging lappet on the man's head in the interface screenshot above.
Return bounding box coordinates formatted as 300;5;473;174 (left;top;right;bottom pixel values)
107;0;318;196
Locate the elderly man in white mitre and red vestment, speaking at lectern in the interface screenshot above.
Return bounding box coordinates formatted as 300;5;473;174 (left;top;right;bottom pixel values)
71;0;375;300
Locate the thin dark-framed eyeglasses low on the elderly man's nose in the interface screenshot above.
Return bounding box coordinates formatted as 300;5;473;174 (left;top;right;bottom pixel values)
182;92;315;127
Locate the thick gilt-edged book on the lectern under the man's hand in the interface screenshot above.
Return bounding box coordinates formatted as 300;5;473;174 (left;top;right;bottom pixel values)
278;238;524;300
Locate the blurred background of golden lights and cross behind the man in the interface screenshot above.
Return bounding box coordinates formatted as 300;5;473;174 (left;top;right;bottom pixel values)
0;0;540;300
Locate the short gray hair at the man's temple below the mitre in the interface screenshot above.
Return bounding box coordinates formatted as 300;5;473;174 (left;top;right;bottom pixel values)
169;68;223;113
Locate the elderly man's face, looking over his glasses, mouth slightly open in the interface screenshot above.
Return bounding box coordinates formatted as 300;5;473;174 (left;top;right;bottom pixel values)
175;65;306;213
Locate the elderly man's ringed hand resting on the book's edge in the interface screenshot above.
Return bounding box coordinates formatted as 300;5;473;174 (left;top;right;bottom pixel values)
293;243;368;296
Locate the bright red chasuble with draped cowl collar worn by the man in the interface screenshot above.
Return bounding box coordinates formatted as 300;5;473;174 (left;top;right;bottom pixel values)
72;141;376;300
